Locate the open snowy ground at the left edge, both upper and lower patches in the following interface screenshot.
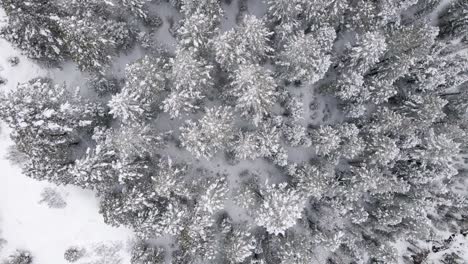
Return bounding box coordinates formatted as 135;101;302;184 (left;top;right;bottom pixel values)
0;13;132;264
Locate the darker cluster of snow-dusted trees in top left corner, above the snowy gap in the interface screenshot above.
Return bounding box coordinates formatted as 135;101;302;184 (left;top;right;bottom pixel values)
0;0;150;72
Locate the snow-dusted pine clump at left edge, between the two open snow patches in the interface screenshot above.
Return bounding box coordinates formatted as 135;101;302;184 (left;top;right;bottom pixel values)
0;78;106;183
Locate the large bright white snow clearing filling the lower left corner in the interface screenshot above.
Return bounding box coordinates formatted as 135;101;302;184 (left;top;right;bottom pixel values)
0;129;132;264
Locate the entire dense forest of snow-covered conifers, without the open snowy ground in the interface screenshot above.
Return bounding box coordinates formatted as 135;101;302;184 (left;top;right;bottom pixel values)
0;0;468;264
